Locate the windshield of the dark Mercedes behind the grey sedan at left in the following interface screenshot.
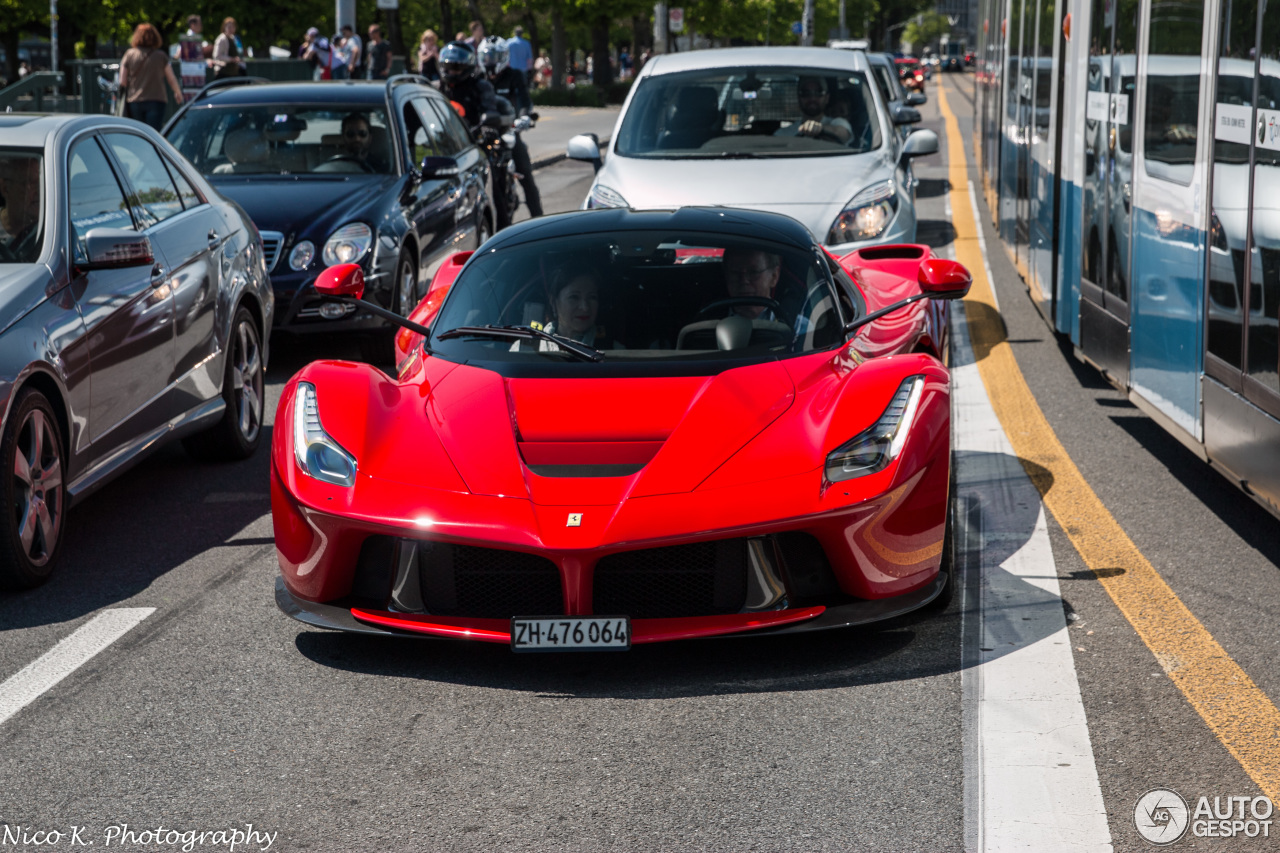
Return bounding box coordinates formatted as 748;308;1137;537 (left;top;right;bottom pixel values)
169;104;396;177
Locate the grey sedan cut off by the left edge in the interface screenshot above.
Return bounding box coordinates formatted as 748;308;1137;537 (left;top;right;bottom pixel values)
0;113;274;589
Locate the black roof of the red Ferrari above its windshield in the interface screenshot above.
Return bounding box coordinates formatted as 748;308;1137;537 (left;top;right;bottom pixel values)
484;207;815;251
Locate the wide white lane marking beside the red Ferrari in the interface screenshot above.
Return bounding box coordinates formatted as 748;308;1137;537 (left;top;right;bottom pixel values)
951;306;1112;853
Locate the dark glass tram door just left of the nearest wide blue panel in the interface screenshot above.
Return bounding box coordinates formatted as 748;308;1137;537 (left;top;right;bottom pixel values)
1080;0;1138;387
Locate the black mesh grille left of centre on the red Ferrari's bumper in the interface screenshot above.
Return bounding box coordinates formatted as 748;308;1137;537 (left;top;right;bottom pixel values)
419;542;564;619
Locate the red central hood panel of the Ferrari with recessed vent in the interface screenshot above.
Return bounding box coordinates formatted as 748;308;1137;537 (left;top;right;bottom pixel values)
419;361;795;507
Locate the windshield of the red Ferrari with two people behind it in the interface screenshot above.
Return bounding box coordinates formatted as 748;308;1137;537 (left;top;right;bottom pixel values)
430;231;855;364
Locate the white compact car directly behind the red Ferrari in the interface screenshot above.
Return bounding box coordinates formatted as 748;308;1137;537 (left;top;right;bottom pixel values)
568;47;938;254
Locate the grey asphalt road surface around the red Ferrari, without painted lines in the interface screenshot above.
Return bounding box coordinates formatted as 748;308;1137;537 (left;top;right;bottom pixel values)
0;83;1280;853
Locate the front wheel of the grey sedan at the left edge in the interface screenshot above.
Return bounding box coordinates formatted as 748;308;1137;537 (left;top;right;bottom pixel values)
0;388;67;589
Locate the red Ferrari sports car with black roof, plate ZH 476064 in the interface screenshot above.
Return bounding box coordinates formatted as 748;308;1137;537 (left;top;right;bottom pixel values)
271;207;969;651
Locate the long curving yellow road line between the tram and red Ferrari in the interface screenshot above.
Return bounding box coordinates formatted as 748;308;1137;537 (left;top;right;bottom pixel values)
937;79;1280;799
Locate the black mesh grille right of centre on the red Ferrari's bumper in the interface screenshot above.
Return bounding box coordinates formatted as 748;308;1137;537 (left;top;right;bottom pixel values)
591;539;746;619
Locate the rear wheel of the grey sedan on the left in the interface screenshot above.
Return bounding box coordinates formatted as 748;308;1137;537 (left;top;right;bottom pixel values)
182;305;266;462
